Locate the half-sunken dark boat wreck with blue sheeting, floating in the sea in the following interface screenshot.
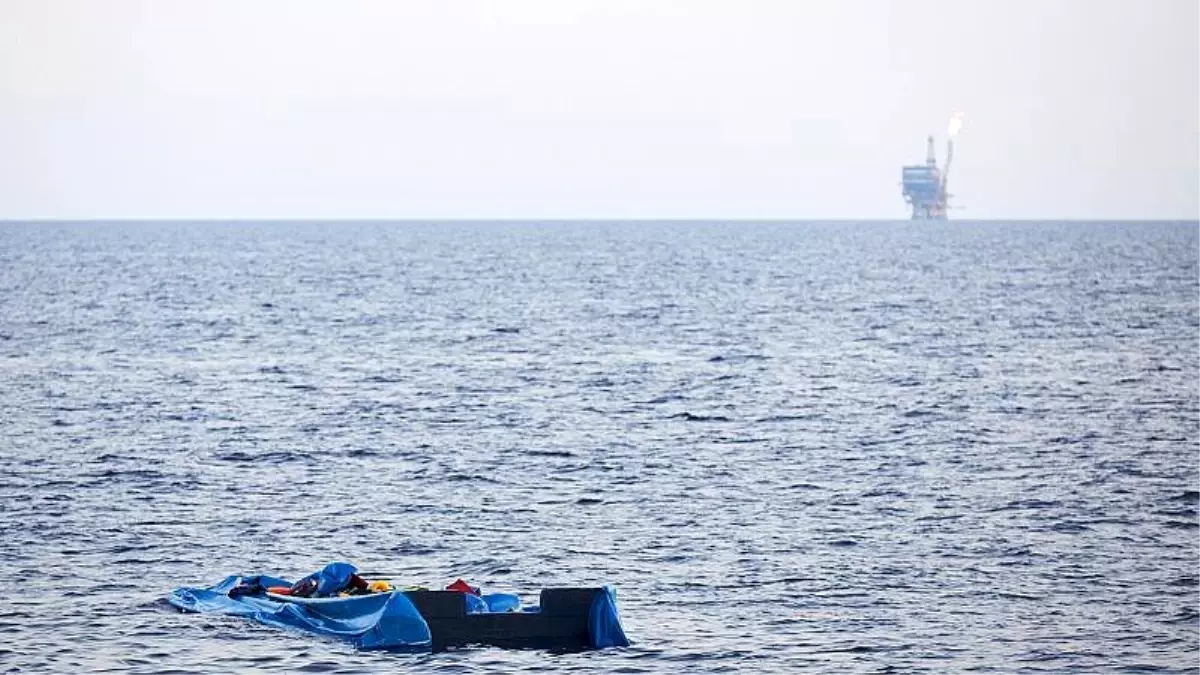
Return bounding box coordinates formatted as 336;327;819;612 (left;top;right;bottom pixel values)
167;562;629;651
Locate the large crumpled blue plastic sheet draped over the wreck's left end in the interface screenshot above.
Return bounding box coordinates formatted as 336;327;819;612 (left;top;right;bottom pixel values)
167;566;433;651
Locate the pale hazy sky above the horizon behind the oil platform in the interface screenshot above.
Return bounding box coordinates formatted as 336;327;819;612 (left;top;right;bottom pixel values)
0;0;1200;219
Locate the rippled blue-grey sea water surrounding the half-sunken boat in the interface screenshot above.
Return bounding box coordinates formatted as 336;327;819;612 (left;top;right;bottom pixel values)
0;222;1200;673
